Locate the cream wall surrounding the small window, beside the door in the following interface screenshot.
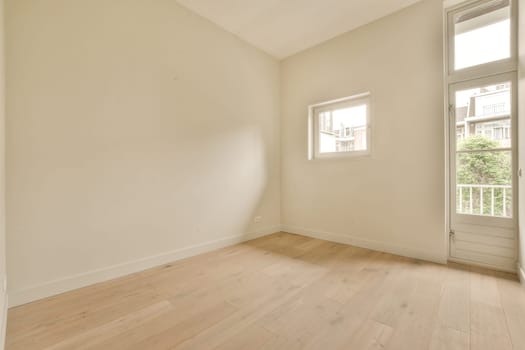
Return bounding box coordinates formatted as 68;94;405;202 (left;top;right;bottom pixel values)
281;0;447;261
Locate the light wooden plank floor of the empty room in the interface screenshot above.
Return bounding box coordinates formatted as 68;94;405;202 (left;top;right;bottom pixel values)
7;233;525;350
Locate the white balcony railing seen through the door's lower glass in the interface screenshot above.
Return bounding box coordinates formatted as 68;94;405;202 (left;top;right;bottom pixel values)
456;184;512;217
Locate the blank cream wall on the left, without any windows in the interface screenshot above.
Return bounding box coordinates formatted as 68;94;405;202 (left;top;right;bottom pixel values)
7;0;280;305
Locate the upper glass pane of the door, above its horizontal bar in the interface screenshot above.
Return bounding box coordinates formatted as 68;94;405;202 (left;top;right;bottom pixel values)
456;83;511;151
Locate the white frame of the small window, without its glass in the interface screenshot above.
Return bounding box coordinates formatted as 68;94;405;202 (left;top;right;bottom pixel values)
308;92;372;160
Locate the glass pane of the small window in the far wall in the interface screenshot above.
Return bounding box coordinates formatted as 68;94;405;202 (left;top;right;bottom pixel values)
319;105;367;153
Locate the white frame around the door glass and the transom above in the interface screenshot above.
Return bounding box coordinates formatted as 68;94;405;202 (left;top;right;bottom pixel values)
443;0;519;271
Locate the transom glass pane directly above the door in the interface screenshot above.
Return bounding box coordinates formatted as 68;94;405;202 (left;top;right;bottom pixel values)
454;0;511;70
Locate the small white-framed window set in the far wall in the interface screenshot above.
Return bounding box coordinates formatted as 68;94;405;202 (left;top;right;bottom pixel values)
309;93;370;159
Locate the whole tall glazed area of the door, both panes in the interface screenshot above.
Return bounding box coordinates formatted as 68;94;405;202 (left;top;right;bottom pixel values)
455;83;512;217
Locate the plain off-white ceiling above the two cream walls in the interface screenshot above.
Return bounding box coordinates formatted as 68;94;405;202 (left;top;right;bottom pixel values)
176;0;420;59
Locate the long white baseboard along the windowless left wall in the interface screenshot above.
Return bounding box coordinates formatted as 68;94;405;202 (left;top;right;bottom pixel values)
9;226;280;308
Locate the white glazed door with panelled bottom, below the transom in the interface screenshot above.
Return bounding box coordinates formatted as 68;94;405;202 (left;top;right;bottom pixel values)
449;73;517;271
